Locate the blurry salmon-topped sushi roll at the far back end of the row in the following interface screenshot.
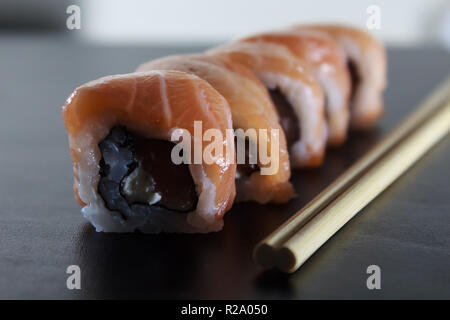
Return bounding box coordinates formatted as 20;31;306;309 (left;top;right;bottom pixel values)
294;25;386;129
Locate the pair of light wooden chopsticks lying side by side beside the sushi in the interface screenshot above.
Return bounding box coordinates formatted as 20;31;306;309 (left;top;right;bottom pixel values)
254;79;450;273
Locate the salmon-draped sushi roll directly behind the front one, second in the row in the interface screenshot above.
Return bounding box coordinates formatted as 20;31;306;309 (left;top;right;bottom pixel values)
137;54;293;203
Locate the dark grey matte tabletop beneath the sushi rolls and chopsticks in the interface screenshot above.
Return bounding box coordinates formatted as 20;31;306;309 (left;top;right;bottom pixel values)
0;35;450;299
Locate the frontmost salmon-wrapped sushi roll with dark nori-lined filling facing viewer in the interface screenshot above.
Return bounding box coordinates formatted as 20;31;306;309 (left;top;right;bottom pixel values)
63;71;236;233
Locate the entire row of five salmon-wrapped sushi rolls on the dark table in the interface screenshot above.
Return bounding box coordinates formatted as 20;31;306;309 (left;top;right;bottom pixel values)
62;25;386;233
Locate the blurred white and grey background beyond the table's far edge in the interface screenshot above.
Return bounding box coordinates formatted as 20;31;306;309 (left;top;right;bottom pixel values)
0;0;450;48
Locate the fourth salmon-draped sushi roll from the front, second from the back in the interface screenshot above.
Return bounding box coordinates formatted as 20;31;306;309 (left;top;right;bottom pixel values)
241;30;350;145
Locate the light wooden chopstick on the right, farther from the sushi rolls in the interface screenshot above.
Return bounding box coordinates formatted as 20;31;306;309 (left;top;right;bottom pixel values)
277;103;450;272
